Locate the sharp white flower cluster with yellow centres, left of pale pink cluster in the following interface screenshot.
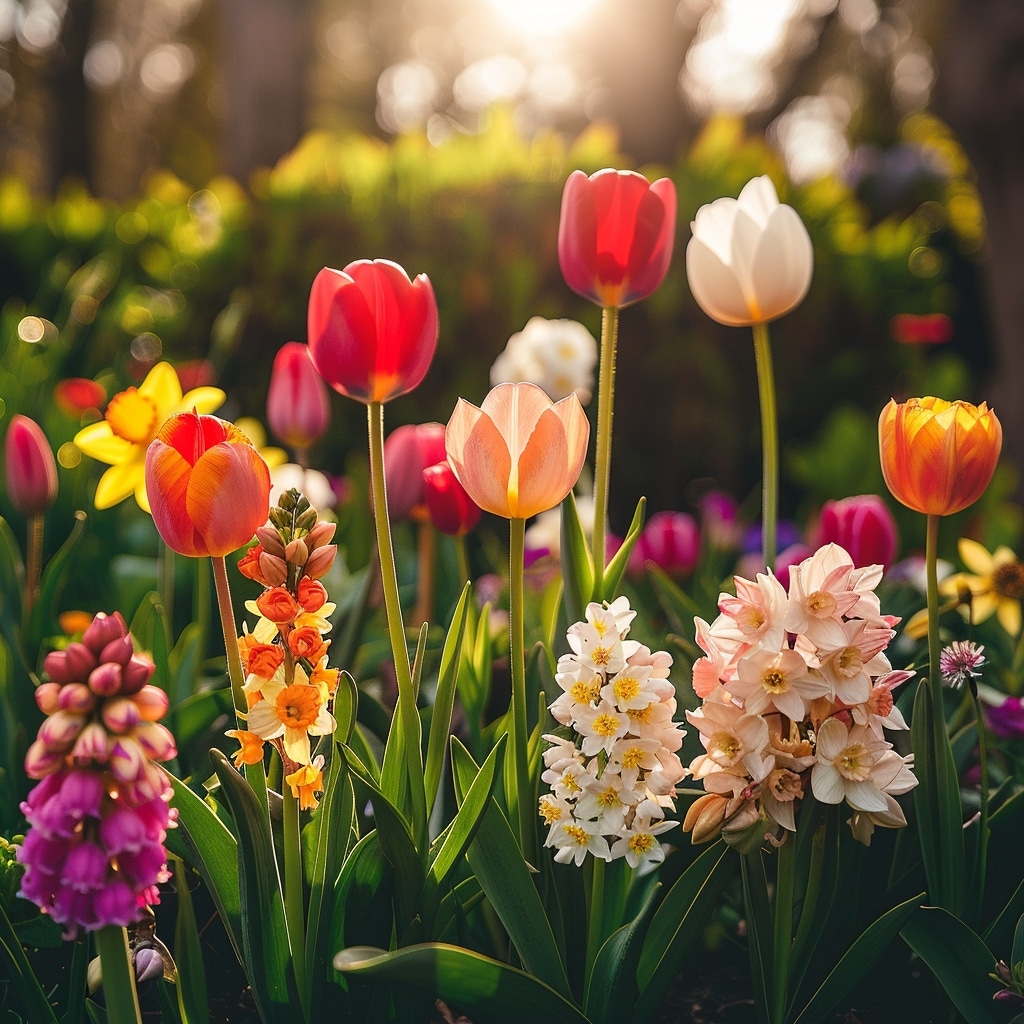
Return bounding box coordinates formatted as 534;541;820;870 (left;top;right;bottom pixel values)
540;597;686;867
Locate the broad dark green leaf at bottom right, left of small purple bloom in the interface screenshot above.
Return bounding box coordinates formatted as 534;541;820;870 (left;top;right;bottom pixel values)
900;906;1004;1024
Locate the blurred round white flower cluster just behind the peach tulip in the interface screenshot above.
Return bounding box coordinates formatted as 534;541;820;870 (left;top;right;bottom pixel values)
490;316;597;404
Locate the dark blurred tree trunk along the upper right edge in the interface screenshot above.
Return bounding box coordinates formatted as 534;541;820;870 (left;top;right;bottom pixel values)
935;0;1024;491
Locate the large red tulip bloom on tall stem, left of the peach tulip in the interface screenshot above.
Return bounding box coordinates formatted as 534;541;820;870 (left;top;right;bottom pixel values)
308;260;437;403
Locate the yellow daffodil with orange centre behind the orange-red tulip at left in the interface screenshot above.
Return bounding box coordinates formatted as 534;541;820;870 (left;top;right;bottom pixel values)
75;362;225;512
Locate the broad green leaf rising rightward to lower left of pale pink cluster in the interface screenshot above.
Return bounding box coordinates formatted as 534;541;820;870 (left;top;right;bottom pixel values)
633;840;738;1021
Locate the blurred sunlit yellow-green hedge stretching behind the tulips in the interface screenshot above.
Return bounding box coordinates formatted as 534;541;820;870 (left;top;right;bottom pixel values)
0;112;988;529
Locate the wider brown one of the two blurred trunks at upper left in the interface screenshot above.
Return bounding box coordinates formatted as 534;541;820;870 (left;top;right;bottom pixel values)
219;0;310;181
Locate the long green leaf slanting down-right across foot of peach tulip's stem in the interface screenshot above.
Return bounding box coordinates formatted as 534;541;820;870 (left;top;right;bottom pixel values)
452;737;571;998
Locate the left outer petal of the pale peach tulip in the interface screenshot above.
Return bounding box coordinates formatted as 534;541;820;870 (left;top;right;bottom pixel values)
444;398;512;519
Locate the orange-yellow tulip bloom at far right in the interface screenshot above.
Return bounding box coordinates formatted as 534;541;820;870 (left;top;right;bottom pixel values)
879;397;1002;515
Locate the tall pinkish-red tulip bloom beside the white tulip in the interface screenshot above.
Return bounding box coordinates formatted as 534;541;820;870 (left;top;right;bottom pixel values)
558;168;676;308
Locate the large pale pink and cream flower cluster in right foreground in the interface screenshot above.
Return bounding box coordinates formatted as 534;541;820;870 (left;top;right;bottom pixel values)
683;544;918;845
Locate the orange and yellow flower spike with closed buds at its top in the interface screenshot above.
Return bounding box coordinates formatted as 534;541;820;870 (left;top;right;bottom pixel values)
227;490;338;810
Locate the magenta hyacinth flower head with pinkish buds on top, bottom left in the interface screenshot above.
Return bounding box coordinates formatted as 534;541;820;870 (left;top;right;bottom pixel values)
17;612;176;936
